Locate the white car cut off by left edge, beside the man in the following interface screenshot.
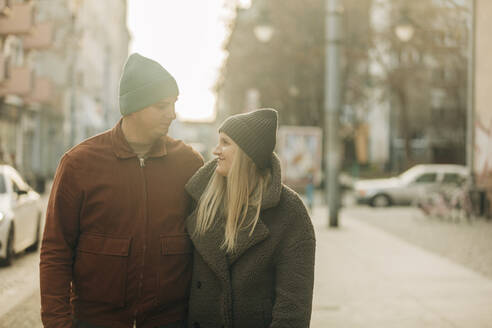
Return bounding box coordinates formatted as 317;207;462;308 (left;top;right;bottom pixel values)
0;165;42;265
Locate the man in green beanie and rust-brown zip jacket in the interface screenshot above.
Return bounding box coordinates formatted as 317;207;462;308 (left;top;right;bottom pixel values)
40;54;203;328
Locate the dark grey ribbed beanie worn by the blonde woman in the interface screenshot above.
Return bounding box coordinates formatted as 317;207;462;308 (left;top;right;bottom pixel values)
219;108;278;169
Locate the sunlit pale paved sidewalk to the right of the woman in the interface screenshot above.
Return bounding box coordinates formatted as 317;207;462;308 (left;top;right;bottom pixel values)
311;207;492;328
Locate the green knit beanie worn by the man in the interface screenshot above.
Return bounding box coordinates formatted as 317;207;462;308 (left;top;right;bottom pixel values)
120;53;179;115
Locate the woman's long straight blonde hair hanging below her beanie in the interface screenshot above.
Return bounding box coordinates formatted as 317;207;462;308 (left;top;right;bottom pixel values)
193;147;271;253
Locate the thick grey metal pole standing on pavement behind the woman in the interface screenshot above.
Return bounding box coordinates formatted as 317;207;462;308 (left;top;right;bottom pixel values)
324;0;343;227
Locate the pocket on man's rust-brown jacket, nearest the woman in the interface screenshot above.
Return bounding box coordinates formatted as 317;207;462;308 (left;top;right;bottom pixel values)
157;234;193;306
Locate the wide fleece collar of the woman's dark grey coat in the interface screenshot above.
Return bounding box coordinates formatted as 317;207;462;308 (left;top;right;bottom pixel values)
185;154;282;274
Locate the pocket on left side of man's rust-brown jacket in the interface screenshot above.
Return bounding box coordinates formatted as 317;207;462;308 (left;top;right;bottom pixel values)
74;234;131;306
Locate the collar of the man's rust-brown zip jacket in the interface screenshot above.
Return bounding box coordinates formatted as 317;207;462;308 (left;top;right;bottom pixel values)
111;118;167;158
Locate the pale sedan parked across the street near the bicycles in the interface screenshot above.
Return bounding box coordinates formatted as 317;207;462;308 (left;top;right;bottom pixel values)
354;164;468;207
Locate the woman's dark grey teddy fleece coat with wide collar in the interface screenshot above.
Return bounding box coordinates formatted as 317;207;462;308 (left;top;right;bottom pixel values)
186;155;315;328
